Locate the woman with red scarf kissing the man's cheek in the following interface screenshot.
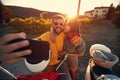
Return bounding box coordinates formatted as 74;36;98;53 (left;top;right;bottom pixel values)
60;18;85;80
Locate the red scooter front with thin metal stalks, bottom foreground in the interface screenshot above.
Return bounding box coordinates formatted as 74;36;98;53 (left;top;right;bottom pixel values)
0;55;68;80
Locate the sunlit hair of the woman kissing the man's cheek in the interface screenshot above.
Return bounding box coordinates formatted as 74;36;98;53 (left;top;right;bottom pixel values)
66;17;80;33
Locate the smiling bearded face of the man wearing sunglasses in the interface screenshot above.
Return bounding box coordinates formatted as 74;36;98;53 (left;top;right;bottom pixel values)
52;19;65;34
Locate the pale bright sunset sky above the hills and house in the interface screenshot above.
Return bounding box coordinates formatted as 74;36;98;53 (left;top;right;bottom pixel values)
1;0;120;16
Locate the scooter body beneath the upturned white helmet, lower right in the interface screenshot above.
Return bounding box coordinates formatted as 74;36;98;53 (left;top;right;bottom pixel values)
85;59;120;80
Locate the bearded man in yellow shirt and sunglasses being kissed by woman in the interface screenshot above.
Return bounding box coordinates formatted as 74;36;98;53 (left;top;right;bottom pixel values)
35;15;71;80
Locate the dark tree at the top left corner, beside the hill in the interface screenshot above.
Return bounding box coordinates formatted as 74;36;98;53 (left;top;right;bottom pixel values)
0;1;13;23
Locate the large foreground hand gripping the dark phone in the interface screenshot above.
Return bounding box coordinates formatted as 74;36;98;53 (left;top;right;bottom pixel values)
0;32;31;63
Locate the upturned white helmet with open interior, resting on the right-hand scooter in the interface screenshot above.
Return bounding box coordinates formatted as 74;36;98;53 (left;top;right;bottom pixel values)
90;44;119;69
